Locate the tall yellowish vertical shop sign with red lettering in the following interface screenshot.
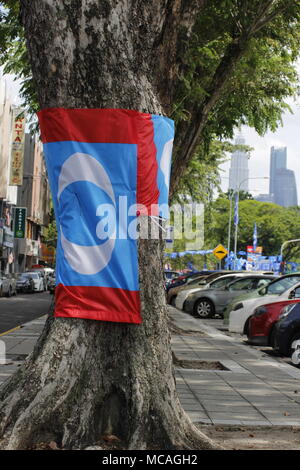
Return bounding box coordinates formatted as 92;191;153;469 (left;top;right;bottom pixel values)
9;108;25;186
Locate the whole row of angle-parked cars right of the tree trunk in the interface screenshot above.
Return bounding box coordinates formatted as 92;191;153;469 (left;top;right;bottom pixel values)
166;271;300;364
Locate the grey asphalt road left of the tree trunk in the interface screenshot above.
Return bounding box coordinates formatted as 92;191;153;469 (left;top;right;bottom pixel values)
0;292;52;334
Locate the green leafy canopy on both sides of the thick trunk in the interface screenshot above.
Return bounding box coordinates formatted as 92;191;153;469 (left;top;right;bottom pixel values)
0;0;300;201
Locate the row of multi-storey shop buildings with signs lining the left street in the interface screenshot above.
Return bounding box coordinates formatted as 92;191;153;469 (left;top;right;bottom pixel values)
0;76;53;273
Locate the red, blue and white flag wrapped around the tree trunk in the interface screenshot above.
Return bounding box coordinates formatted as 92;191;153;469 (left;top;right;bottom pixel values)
38;108;174;323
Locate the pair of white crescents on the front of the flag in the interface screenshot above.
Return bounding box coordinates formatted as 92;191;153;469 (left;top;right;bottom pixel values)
57;152;116;275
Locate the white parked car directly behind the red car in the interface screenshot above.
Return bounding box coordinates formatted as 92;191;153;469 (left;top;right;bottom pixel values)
228;274;300;334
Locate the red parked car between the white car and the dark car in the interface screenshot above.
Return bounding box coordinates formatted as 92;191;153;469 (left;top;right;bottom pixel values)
247;299;300;346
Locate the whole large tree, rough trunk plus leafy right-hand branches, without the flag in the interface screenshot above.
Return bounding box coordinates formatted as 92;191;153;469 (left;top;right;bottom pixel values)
0;0;299;449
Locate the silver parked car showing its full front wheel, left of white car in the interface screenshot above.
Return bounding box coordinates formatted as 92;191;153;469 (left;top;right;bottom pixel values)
184;273;272;318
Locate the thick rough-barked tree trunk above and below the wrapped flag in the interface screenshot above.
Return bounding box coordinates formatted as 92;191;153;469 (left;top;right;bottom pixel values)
0;0;214;449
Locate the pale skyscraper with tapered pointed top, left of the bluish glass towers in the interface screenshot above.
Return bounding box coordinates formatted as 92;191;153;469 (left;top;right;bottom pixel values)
229;134;249;191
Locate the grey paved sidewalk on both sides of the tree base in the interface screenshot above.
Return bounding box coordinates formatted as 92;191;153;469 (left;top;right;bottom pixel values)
0;307;300;426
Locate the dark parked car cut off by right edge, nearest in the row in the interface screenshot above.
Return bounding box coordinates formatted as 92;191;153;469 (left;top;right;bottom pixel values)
274;300;300;357
